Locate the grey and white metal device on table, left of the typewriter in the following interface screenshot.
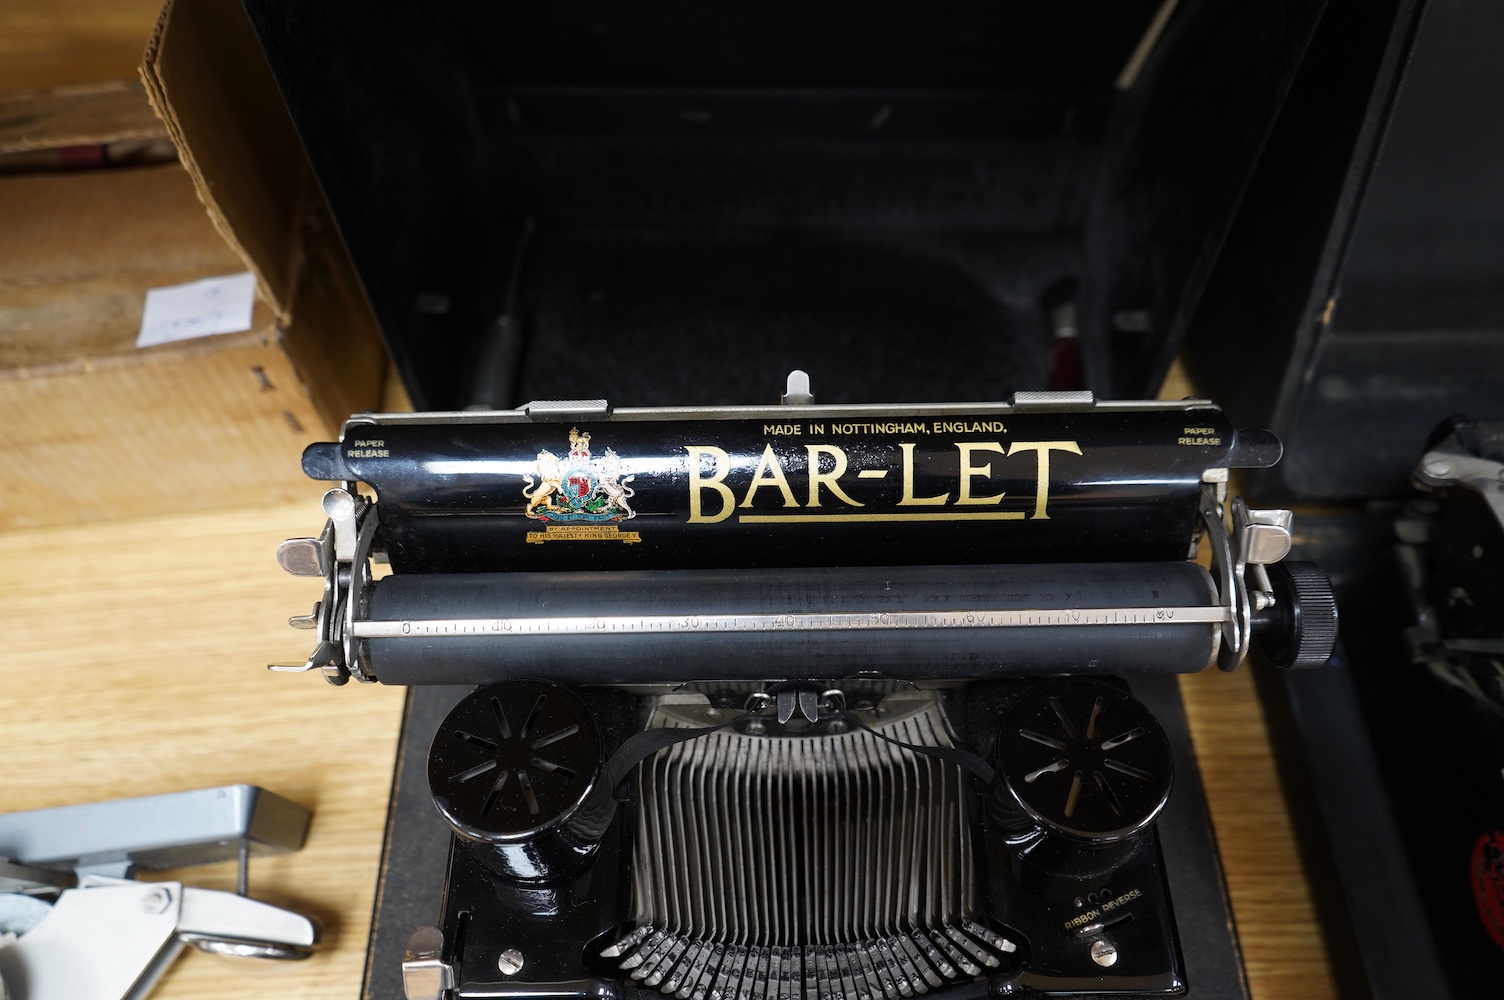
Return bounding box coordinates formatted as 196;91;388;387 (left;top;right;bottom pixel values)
0;785;317;1000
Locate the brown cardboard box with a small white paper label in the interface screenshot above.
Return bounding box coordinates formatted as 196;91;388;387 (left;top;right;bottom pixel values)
0;74;385;529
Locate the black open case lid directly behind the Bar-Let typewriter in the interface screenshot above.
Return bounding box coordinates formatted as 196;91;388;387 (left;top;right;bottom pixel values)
225;0;1325;409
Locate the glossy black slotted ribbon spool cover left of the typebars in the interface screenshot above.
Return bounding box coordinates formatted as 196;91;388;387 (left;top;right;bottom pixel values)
429;680;609;881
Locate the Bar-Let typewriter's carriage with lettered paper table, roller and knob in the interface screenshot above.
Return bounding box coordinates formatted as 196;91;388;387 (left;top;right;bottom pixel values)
277;394;1336;683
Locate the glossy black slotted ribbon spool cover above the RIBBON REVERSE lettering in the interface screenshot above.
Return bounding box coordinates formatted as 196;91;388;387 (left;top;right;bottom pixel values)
994;678;1175;877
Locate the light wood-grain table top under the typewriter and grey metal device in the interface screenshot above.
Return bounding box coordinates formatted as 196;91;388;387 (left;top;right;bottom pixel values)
0;484;1336;1000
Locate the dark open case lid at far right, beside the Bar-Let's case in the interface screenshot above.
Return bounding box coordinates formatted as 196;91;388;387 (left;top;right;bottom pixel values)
1185;0;1504;502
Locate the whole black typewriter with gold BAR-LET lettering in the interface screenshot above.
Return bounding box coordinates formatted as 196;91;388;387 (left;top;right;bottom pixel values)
274;381;1336;1000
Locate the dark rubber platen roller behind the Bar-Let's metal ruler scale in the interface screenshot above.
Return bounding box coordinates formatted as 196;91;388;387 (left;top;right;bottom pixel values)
362;562;1220;684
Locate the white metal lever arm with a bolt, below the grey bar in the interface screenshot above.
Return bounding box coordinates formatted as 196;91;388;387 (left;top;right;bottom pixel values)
0;877;317;1000
